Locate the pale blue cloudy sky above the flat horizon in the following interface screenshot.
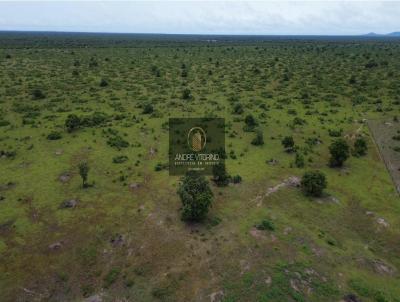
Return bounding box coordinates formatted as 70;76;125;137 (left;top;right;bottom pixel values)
0;0;400;35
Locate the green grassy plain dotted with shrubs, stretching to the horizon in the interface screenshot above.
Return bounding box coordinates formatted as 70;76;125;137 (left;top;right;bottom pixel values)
0;34;400;302
